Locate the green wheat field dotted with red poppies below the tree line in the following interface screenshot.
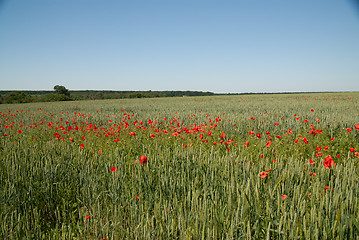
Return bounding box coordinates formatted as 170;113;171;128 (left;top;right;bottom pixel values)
0;93;359;239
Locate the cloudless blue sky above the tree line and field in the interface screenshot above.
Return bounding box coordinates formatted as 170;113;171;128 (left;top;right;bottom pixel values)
0;0;359;93
